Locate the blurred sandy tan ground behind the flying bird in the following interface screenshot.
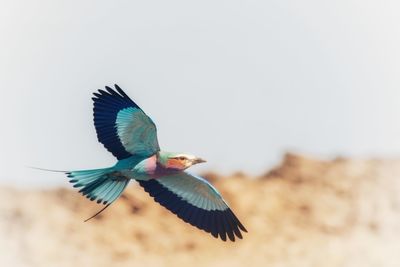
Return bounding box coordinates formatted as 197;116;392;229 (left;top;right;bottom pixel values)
0;154;400;267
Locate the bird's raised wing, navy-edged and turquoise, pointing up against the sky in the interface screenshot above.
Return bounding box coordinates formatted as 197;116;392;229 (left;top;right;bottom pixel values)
92;85;160;160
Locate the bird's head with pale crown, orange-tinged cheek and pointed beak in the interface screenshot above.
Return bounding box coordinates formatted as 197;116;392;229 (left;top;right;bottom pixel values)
158;152;206;170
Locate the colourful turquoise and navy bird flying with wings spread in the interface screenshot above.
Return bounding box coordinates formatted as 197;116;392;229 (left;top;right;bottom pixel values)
63;84;247;242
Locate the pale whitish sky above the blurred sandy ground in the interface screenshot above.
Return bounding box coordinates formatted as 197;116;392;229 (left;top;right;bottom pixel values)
0;0;400;185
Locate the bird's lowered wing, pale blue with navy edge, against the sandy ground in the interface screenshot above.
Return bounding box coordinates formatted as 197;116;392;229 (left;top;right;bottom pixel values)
138;172;247;241
